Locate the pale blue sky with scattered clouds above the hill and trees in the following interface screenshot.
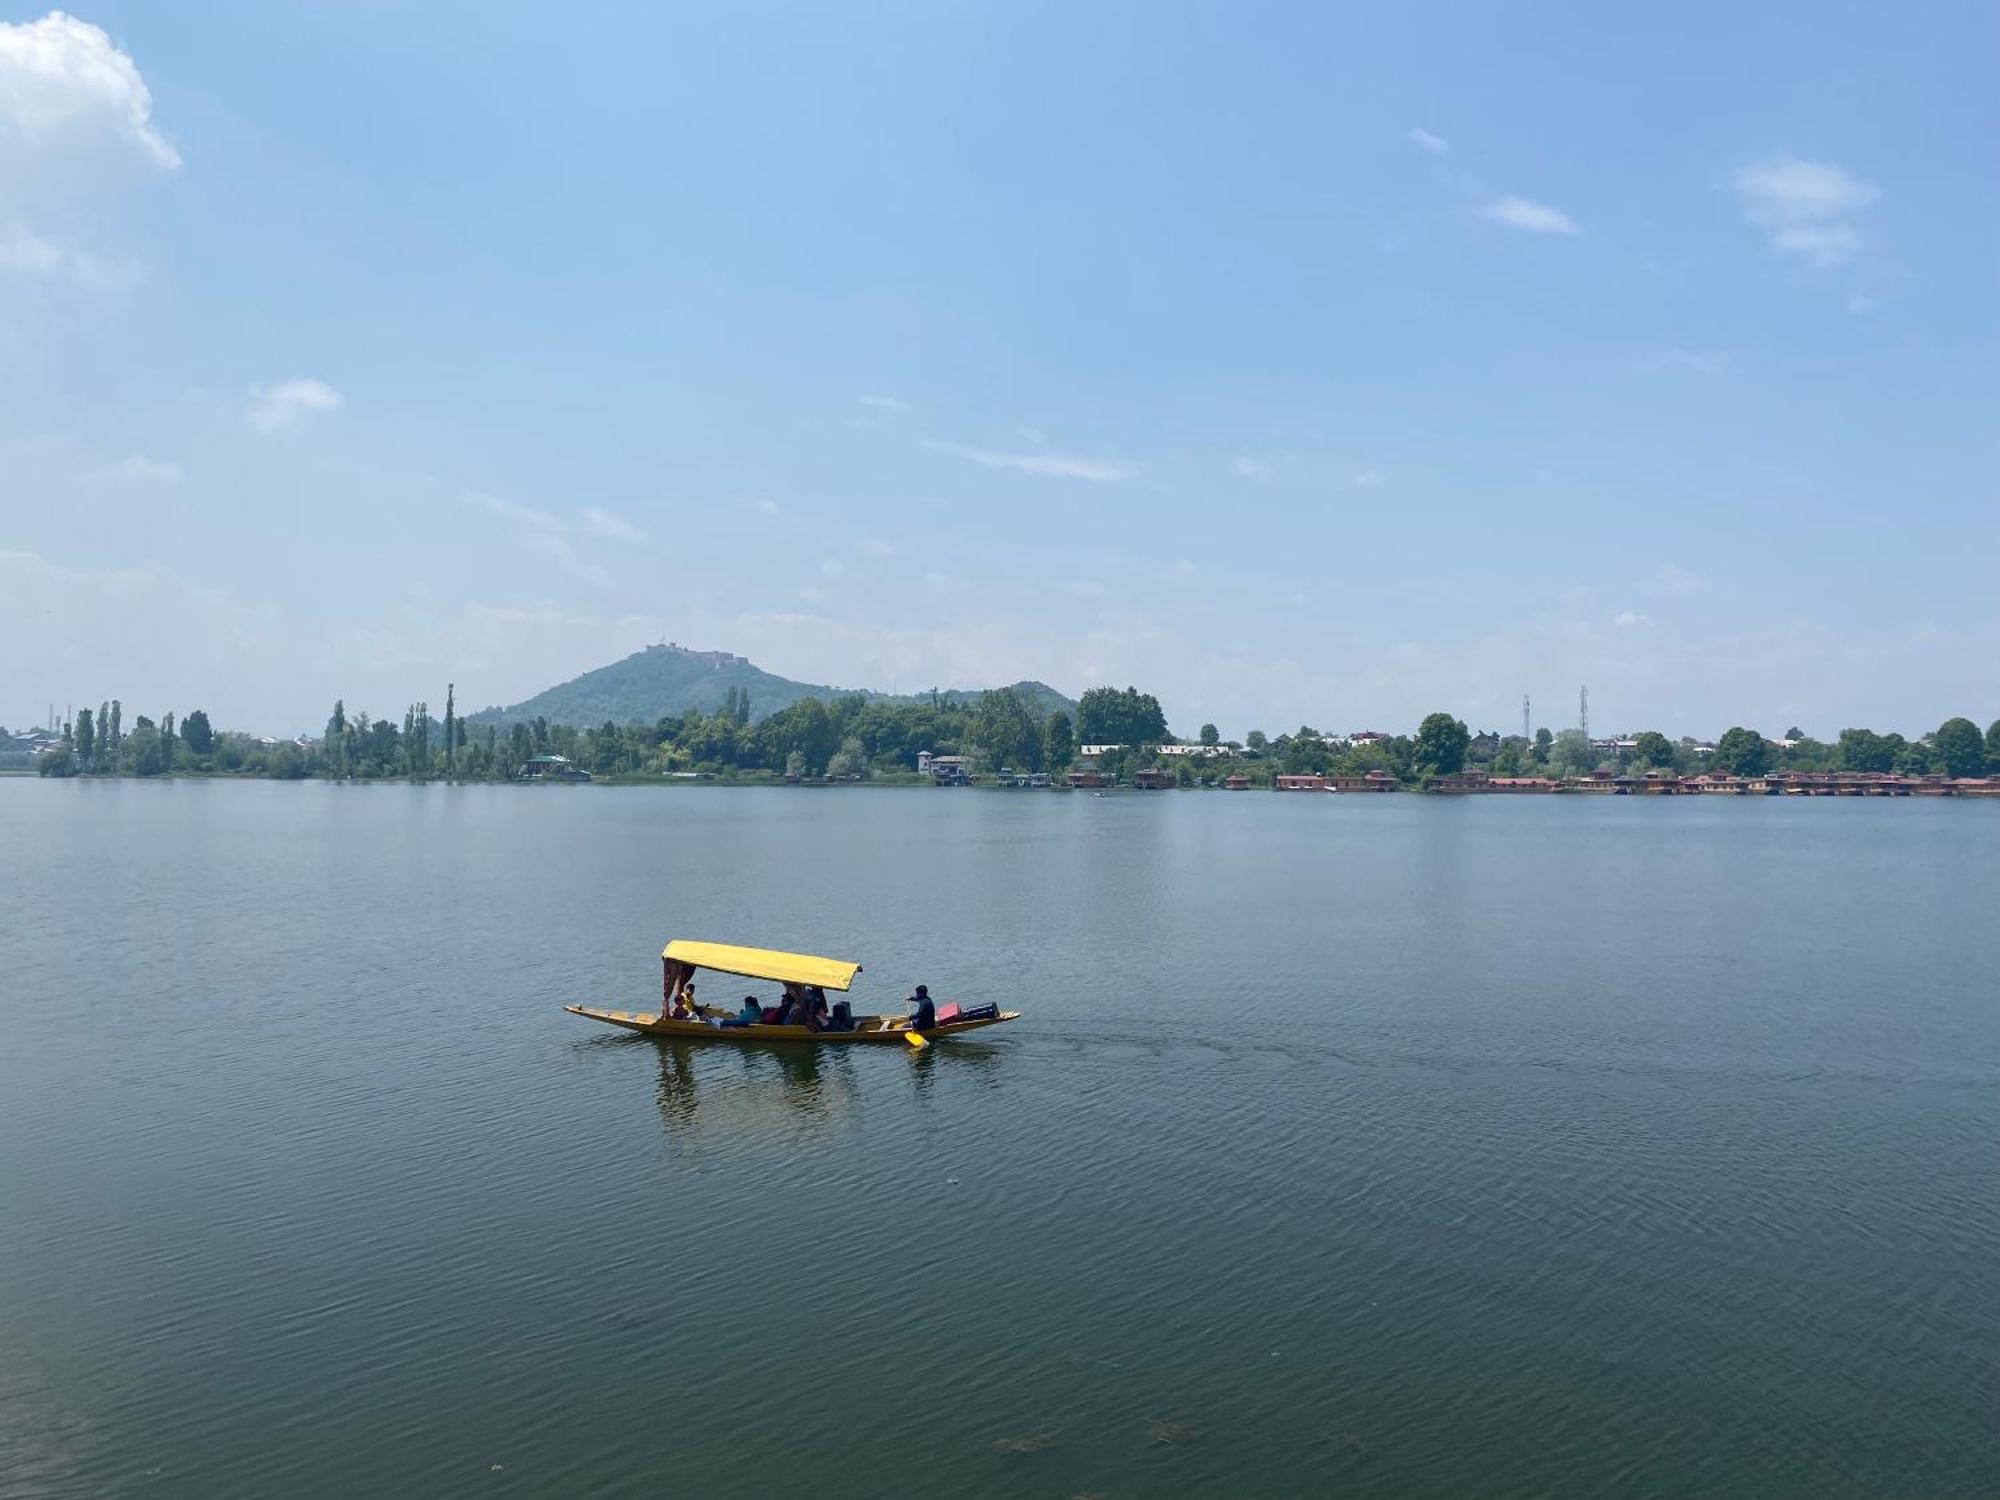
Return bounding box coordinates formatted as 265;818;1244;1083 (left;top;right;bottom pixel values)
0;0;2000;738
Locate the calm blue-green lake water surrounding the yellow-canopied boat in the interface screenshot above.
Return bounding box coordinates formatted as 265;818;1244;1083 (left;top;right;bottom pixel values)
0;780;2000;1498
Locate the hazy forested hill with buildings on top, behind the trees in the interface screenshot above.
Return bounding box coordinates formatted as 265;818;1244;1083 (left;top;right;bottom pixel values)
466;646;1076;728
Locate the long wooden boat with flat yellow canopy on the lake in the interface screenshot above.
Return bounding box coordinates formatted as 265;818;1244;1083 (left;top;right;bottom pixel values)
564;938;1020;1046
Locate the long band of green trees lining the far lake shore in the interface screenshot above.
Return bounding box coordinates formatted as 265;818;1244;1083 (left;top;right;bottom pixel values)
36;686;2000;786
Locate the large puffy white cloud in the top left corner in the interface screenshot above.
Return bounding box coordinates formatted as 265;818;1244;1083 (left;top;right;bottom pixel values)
0;10;180;172
